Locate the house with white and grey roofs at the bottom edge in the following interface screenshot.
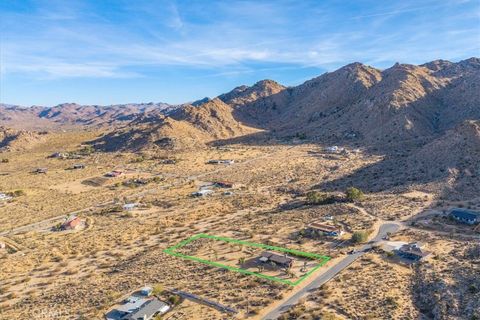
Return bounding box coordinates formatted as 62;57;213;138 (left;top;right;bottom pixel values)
106;287;170;320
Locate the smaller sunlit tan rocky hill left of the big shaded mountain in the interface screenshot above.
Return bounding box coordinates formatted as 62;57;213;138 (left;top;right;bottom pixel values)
93;99;258;151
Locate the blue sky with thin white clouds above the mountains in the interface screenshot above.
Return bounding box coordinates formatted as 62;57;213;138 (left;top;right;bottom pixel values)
0;0;480;106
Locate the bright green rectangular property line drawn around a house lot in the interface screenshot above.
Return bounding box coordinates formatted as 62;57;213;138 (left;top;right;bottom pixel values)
163;233;331;286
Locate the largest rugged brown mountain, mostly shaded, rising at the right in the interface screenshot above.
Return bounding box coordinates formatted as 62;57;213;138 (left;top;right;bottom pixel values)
239;58;480;146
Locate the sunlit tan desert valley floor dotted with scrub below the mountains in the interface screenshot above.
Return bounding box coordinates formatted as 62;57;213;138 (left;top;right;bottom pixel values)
0;130;480;320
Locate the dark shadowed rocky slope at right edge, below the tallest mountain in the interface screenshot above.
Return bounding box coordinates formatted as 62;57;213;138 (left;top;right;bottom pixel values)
319;120;480;197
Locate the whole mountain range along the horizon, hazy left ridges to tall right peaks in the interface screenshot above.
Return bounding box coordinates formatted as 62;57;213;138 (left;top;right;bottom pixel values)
0;58;480;150
